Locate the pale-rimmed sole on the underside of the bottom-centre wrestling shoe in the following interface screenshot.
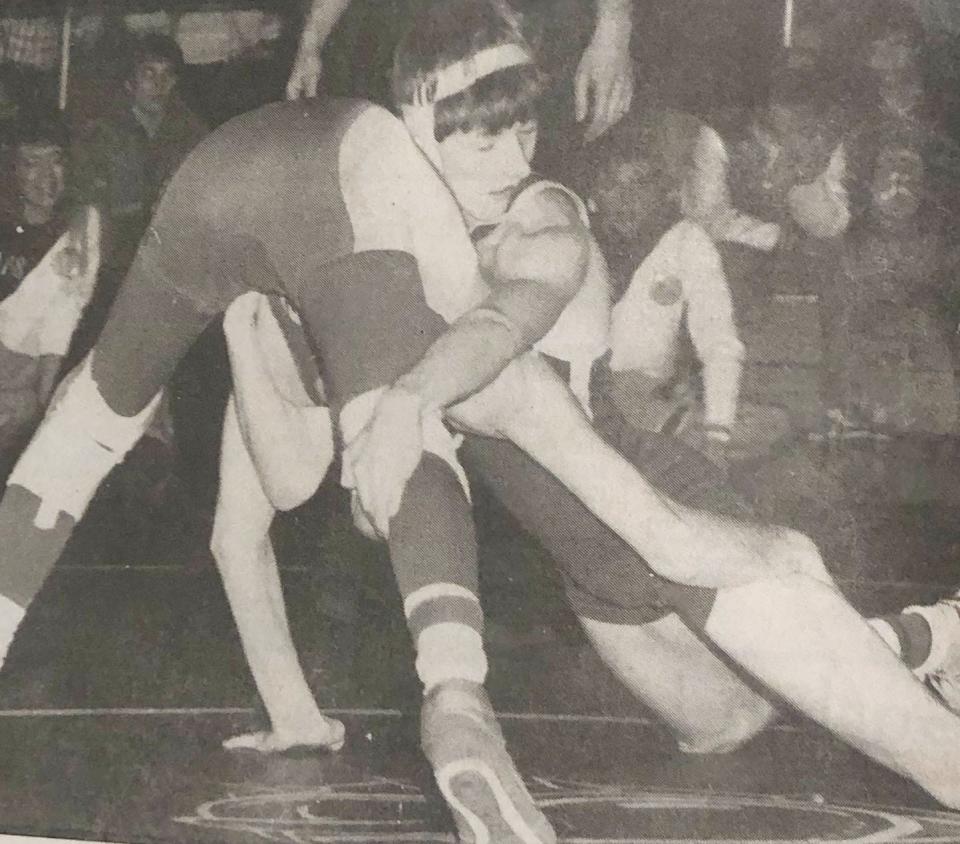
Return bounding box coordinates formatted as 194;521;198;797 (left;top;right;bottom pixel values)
436;758;556;844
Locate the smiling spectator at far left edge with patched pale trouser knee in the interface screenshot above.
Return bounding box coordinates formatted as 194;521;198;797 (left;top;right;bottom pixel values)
0;115;99;465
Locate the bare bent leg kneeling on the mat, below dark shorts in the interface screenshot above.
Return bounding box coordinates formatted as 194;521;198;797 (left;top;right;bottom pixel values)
580;615;776;753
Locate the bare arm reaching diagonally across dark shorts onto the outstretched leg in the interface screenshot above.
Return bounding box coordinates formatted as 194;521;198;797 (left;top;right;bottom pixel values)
448;354;829;588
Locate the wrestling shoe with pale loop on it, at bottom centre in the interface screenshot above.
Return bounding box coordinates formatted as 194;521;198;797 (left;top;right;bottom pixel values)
420;680;557;844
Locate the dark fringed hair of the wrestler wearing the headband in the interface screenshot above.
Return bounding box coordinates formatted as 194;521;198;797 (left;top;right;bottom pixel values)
392;0;546;141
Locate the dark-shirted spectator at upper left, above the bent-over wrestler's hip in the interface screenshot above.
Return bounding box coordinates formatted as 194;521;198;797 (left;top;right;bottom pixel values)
73;35;207;270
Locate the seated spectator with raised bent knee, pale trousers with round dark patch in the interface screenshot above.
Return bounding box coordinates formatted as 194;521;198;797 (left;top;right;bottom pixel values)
588;109;779;464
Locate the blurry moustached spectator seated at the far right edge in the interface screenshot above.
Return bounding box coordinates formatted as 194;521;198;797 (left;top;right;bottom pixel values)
835;132;960;434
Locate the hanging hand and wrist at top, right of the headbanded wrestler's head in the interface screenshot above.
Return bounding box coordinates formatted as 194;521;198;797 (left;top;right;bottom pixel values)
574;0;634;141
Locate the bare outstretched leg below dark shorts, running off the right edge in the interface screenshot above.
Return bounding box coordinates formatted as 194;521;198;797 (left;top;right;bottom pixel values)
706;574;960;808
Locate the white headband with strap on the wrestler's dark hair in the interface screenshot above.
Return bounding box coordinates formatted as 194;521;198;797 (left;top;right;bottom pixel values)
400;44;533;170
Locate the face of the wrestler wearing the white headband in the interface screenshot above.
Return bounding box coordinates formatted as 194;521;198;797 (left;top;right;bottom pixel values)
439;120;537;221
